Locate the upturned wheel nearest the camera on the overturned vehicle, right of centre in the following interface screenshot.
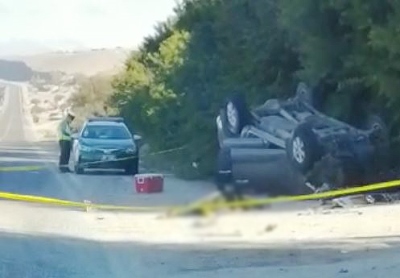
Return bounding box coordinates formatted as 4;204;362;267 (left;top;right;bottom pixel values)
286;122;322;174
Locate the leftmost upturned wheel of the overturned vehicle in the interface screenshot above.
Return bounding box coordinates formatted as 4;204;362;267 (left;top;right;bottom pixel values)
220;94;250;137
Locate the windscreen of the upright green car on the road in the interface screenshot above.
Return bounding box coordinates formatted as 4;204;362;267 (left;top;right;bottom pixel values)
82;125;132;140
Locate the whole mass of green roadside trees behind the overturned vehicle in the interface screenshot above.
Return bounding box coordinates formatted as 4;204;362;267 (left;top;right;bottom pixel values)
69;0;400;177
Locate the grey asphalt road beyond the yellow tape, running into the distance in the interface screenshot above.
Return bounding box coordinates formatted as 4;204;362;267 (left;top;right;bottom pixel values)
0;86;212;206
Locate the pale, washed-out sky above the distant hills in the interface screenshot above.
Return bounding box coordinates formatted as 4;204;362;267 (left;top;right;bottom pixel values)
0;0;176;54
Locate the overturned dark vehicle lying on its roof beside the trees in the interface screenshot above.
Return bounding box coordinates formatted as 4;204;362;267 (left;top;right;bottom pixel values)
216;83;389;199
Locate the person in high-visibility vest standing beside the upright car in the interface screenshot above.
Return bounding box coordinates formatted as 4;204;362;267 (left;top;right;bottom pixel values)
58;111;75;173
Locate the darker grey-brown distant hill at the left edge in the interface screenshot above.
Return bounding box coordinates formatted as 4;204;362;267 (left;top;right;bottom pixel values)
0;60;34;82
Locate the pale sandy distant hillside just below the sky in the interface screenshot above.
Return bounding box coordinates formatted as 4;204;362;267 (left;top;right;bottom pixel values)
5;48;130;76
